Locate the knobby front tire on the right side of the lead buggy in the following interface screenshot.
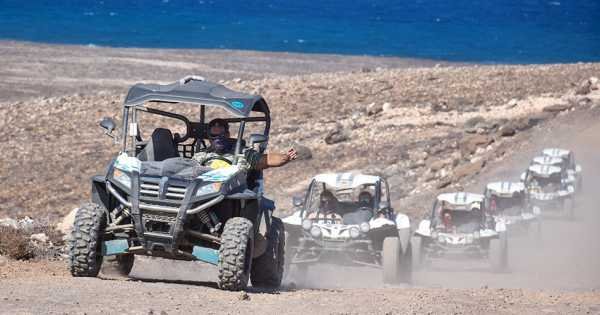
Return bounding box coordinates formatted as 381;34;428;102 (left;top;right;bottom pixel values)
218;217;254;291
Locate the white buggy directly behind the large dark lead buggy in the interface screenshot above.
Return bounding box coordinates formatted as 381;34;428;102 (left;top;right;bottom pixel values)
283;173;412;283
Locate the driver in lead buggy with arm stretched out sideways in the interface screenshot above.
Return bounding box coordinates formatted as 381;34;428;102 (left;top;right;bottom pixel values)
192;118;298;171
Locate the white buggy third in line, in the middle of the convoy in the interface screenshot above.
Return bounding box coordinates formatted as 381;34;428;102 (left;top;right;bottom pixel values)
411;192;508;272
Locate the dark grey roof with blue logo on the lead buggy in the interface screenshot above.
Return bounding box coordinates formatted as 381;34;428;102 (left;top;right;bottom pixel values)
124;76;269;117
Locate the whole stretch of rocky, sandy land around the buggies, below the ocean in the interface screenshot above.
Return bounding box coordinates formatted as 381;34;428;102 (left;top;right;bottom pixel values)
0;42;600;314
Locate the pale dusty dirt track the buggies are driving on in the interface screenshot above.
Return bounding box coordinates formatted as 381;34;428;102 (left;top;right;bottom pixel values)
0;113;600;314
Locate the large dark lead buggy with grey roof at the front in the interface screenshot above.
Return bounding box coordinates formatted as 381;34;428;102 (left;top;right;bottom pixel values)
69;76;285;290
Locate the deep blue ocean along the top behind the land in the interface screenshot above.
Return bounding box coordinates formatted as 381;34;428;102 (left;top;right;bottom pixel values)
0;0;600;63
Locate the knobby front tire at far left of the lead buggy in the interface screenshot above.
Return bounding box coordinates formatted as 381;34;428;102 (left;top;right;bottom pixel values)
69;203;106;277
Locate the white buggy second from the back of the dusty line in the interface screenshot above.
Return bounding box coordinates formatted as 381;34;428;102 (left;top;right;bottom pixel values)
522;164;575;219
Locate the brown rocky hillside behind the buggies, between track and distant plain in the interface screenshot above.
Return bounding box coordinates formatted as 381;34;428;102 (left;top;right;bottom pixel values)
0;64;600;218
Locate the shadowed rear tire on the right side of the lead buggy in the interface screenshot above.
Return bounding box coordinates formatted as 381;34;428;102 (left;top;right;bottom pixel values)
250;217;285;289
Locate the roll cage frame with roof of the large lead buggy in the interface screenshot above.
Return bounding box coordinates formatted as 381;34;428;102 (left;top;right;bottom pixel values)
116;76;271;163
